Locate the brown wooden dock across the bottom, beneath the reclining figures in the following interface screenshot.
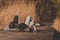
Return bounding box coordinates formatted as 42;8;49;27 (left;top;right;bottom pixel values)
0;27;54;40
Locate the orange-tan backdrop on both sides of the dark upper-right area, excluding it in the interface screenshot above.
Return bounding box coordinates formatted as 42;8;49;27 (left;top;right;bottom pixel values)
0;0;60;31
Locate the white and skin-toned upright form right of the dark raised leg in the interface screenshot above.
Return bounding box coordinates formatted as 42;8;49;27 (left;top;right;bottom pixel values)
25;16;37;32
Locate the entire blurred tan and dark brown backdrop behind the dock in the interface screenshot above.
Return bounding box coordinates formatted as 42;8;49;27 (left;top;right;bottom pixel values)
0;0;60;31
